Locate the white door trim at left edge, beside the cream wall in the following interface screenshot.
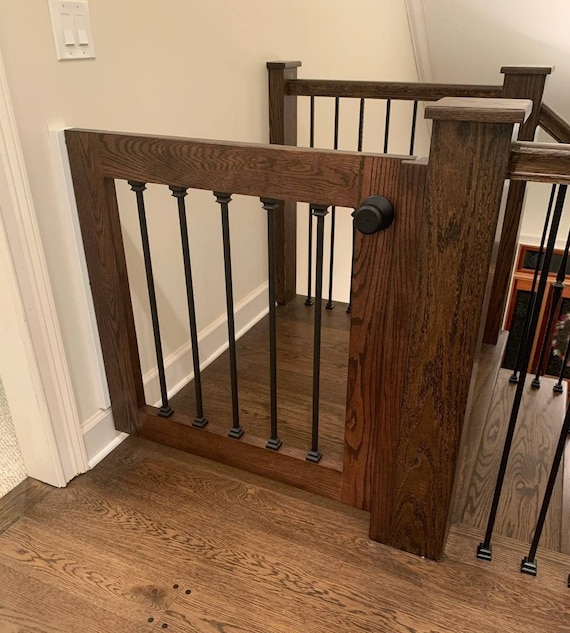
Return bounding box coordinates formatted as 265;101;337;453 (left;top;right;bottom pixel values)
0;44;89;486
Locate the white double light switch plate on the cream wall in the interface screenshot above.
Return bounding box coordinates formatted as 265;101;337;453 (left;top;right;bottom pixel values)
49;0;95;60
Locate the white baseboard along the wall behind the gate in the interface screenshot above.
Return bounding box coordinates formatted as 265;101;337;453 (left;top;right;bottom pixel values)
81;282;269;468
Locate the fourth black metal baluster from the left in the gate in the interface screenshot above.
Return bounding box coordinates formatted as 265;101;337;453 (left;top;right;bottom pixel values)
261;198;283;451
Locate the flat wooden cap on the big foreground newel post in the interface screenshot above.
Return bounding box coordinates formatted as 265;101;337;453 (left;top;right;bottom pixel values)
425;97;532;123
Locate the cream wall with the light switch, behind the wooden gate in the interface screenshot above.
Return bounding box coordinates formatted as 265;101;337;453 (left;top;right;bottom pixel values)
0;0;417;459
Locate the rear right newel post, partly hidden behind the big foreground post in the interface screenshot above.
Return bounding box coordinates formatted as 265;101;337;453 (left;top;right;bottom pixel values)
483;66;552;345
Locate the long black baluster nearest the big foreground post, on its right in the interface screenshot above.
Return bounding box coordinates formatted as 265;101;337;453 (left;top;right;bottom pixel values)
477;185;567;560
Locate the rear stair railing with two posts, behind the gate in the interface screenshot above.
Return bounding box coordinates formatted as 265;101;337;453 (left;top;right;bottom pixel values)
267;61;552;345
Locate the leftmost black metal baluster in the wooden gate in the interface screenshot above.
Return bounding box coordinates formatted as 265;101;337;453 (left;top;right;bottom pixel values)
128;180;174;418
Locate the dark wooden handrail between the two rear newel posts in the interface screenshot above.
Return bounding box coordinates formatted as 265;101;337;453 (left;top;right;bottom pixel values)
286;79;502;101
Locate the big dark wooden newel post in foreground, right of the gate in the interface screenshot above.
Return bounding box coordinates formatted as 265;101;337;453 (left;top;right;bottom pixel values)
370;98;532;560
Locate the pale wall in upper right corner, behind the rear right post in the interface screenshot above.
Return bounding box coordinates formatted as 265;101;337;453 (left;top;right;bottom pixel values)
424;0;570;243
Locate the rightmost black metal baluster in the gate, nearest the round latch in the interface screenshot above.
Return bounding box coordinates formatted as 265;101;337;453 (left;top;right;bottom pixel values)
306;204;328;464
